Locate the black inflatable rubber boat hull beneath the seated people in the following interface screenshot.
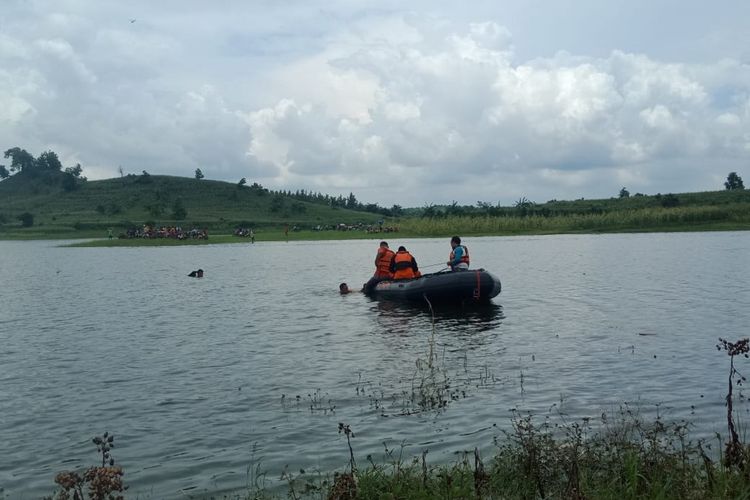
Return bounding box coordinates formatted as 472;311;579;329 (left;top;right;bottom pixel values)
365;269;502;303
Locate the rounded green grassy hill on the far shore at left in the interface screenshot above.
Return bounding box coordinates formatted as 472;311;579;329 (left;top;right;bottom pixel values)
0;173;380;237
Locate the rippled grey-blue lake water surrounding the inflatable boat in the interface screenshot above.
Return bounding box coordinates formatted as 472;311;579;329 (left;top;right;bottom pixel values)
0;232;750;499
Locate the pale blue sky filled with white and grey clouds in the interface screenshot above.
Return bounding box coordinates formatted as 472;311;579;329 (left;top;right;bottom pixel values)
0;0;750;206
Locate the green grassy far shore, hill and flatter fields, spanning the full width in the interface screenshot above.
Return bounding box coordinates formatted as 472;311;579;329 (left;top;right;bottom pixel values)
0;170;750;242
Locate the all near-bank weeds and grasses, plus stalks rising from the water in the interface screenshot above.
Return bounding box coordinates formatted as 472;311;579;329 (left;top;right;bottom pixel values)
45;337;750;500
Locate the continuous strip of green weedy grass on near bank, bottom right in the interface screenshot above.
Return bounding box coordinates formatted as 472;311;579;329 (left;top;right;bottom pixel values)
237;405;750;500
